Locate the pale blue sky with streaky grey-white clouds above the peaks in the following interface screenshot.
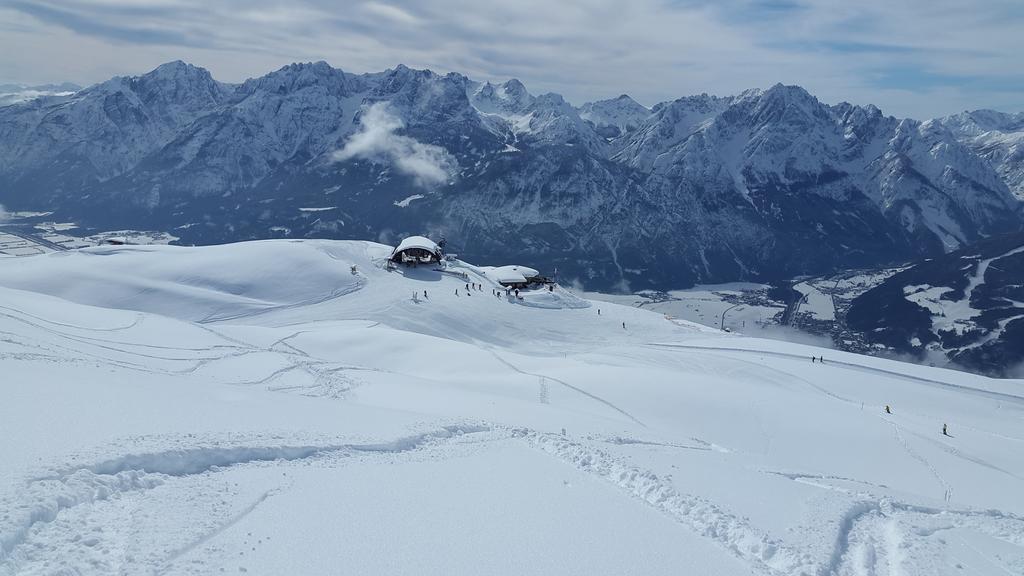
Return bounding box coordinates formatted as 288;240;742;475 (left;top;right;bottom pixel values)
0;0;1024;118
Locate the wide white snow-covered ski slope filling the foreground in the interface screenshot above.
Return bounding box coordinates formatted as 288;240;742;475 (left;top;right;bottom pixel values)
0;241;1024;576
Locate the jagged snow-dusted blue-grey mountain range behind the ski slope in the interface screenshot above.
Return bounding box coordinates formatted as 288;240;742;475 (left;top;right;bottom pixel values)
0;61;1024;289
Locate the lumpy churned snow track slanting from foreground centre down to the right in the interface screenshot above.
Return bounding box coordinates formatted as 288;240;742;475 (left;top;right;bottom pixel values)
520;428;822;576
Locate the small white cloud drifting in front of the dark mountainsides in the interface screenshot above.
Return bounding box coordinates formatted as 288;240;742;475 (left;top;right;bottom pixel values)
334;102;458;188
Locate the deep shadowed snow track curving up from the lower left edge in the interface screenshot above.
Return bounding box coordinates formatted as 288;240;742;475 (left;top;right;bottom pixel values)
0;424;490;561
